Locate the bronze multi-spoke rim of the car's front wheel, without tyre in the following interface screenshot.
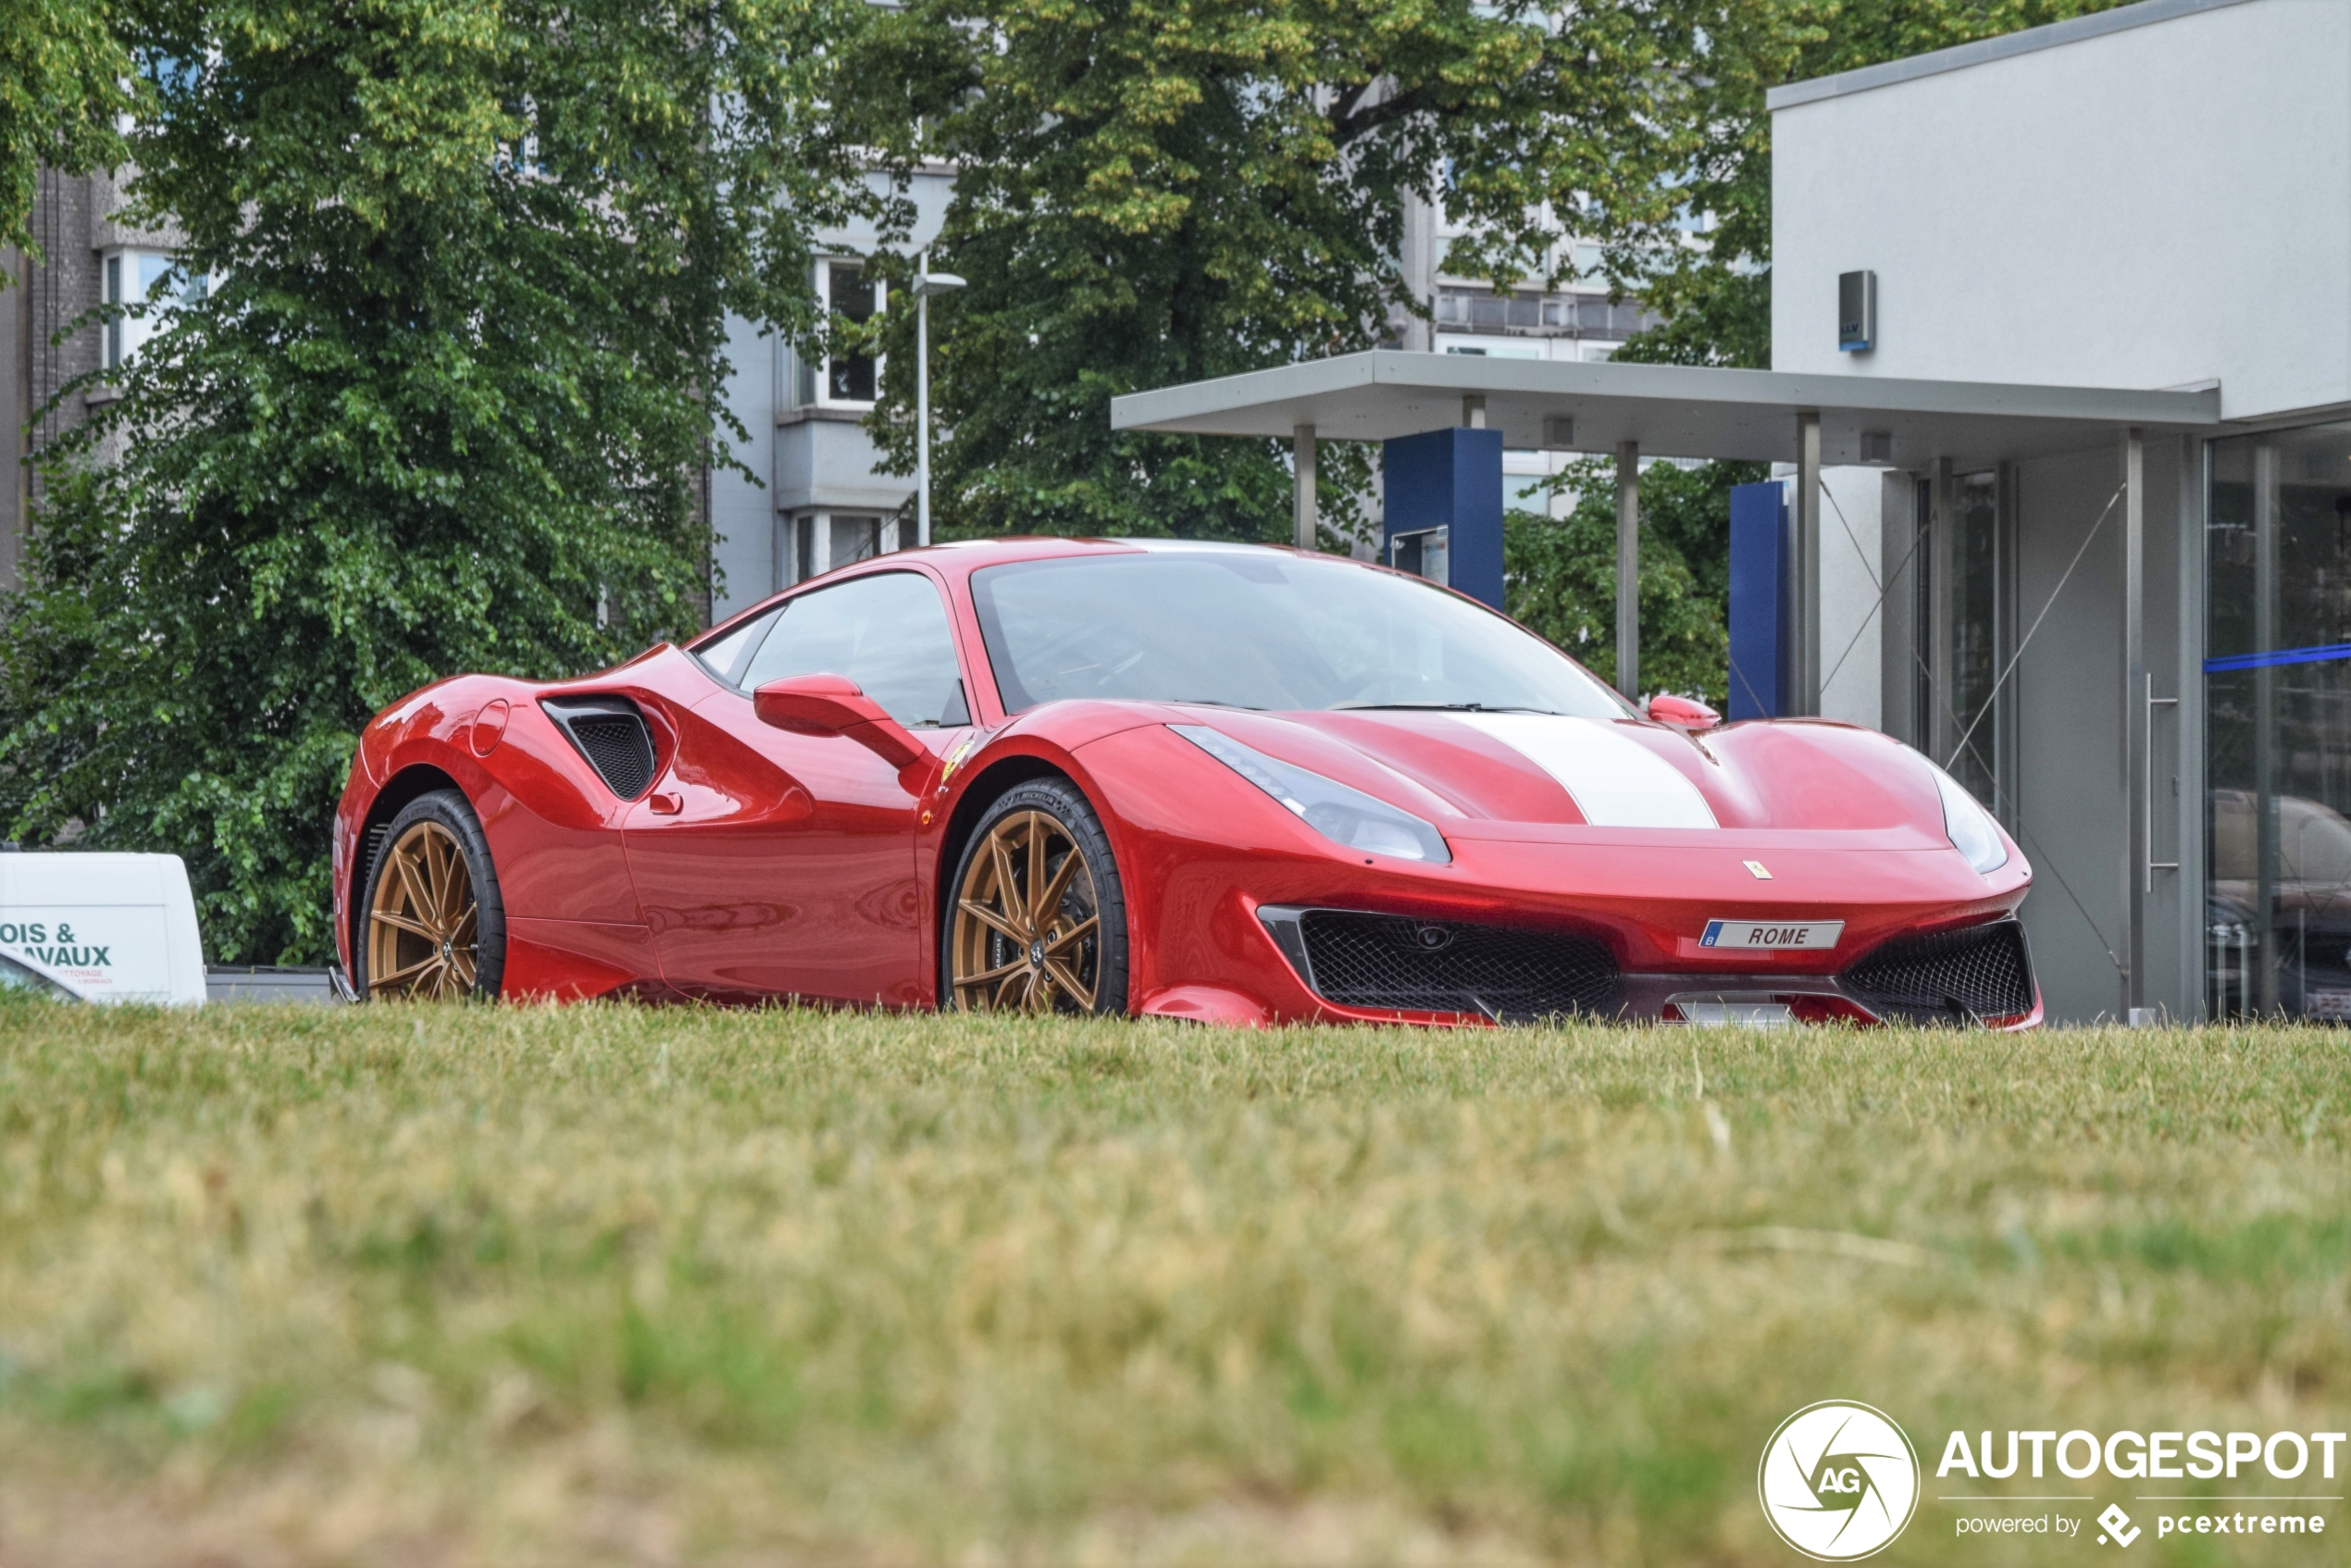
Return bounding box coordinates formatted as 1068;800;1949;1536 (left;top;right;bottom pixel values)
948;811;1102;1014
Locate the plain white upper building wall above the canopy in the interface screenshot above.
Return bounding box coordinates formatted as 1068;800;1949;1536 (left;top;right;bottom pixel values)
1773;0;2351;418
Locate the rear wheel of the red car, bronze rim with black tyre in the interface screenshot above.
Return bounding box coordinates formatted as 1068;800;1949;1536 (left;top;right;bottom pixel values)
350;790;505;1002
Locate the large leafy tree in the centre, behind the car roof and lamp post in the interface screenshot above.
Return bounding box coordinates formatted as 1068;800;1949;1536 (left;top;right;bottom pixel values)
853;0;1699;539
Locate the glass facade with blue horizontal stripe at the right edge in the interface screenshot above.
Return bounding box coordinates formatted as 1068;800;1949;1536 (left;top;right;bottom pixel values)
2203;423;2351;1020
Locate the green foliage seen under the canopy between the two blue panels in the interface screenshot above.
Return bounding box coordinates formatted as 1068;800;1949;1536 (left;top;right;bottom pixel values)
1502;458;1768;710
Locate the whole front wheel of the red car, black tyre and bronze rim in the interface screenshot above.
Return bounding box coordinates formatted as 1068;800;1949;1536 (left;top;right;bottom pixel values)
938;778;1126;1014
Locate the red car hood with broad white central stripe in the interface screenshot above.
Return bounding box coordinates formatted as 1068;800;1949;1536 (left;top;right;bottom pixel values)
1168;707;1949;849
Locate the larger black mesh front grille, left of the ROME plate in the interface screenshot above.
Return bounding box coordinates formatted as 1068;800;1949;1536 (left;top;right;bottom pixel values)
1267;910;1618;1020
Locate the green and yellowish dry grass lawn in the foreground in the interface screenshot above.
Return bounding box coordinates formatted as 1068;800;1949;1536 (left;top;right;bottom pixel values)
0;1003;2351;1565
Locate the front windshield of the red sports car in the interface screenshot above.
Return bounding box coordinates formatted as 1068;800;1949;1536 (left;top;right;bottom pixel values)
971;548;1632;719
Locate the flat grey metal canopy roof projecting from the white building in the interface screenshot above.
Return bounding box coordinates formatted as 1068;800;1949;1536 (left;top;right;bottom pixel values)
1110;348;2220;467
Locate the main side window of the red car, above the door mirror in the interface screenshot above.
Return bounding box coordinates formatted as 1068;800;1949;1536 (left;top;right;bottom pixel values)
736;571;971;727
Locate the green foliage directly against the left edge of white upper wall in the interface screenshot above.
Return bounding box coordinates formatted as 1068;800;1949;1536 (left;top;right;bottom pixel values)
1611;0;2125;369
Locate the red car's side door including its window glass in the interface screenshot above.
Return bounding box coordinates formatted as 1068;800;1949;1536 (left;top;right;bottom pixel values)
623;571;971;1006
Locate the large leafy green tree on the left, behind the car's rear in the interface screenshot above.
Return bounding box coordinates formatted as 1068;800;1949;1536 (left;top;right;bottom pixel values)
0;0;870;959
